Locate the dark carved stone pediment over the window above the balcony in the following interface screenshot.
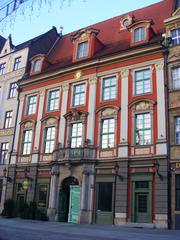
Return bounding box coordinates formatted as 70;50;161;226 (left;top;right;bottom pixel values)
64;109;88;122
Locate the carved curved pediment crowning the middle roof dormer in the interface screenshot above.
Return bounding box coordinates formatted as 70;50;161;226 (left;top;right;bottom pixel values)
71;28;99;42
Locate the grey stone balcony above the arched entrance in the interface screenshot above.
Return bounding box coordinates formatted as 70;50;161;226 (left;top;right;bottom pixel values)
53;147;96;161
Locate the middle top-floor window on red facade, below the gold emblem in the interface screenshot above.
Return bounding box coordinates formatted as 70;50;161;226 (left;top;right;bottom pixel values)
73;83;86;106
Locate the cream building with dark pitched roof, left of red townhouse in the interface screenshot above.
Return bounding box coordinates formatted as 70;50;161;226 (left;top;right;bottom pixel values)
0;28;58;211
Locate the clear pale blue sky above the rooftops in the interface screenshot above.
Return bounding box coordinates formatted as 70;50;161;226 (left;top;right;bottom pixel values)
0;0;160;45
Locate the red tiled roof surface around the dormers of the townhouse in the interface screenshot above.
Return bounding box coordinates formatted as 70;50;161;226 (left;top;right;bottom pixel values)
48;0;175;68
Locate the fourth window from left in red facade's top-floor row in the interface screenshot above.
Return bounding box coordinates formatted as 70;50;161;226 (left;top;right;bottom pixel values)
102;76;117;101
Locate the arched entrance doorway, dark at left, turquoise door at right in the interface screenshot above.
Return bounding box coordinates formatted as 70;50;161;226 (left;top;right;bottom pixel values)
59;177;80;223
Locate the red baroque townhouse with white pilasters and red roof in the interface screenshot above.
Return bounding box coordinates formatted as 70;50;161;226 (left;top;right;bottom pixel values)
6;0;175;228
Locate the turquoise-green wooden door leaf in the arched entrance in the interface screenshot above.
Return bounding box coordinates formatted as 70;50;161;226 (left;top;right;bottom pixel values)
68;186;80;223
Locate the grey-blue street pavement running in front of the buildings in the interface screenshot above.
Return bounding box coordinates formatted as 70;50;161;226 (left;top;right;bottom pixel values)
0;218;180;240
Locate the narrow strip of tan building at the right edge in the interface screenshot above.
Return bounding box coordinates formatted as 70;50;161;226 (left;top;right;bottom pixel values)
165;1;180;229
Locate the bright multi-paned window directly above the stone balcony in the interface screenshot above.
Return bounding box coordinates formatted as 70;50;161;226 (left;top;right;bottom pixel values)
71;123;83;148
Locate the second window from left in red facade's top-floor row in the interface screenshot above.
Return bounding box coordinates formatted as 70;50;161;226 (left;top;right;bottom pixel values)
47;90;59;111
